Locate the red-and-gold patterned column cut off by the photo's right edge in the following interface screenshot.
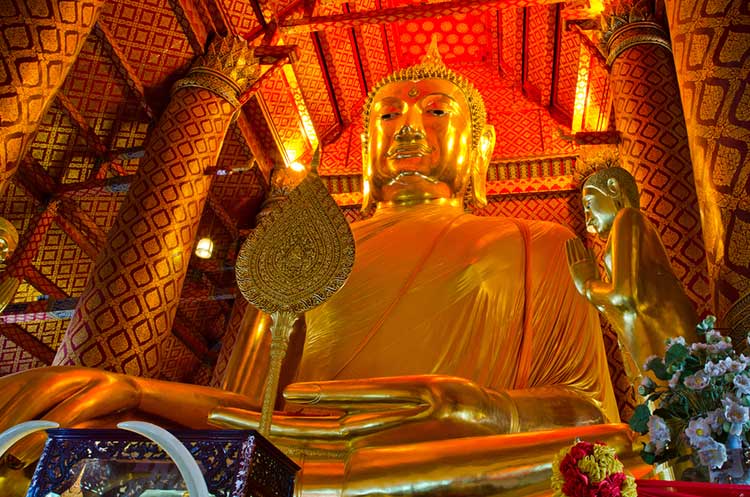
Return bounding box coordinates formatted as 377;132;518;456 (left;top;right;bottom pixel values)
665;0;750;332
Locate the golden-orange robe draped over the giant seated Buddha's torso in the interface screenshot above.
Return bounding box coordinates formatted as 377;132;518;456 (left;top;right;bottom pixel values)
297;204;619;421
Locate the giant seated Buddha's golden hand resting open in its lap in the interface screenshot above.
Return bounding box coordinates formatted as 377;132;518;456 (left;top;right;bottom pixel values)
209;375;513;442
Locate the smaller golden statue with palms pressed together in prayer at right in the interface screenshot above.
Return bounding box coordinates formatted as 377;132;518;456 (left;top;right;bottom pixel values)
567;158;698;374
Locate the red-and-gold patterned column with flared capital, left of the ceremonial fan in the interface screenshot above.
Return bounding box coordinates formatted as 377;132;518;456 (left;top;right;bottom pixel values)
54;38;259;377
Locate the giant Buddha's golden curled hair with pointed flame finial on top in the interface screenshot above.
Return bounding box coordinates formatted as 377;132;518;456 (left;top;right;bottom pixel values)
362;37;487;149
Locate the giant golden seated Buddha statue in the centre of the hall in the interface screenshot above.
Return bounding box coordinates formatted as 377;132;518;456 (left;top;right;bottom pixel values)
0;43;648;496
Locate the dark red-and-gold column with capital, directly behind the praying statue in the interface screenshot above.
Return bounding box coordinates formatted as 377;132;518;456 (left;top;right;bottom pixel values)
604;10;710;315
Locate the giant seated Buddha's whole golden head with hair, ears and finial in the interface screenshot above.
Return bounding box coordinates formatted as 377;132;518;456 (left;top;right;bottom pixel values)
362;39;495;210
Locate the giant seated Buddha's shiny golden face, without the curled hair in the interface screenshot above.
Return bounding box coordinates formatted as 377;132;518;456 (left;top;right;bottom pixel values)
365;79;472;203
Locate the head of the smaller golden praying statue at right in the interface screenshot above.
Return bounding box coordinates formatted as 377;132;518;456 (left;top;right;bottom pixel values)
581;165;640;238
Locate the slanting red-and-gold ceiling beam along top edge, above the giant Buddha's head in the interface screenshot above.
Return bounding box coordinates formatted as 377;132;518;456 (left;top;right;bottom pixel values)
279;0;563;33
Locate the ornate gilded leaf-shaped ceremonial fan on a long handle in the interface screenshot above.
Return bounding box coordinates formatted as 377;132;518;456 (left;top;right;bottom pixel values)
236;150;354;435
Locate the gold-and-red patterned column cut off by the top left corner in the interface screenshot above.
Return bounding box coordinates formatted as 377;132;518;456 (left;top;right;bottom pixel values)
0;0;104;195
